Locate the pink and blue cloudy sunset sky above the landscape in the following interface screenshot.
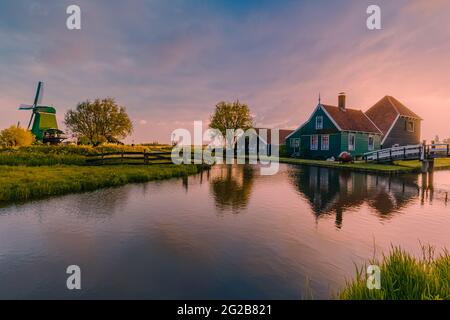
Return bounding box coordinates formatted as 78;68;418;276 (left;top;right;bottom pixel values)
0;0;450;143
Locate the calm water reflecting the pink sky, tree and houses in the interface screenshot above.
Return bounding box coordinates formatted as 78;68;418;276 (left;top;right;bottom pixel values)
0;165;450;299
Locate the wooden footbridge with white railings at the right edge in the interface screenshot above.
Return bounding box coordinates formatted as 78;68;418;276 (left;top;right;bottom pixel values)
363;143;450;172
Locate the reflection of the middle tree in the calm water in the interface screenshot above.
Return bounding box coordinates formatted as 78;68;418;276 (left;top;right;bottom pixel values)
209;165;255;213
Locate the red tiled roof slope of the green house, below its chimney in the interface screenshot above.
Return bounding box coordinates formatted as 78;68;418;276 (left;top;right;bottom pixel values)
322;104;381;134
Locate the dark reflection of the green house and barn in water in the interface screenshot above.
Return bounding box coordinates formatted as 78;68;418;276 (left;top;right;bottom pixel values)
289;166;418;228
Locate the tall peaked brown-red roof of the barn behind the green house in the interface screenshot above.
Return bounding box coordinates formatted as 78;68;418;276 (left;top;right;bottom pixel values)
366;96;422;135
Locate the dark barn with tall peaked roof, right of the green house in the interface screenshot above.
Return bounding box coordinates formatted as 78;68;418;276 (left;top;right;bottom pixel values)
366;96;422;148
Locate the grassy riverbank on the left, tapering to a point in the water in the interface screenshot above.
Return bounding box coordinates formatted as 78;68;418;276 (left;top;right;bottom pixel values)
0;165;207;204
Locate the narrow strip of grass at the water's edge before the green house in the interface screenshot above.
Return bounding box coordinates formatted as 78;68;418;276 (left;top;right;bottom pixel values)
280;158;420;173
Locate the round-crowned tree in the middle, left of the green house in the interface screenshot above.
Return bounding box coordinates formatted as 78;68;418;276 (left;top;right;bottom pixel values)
209;100;253;147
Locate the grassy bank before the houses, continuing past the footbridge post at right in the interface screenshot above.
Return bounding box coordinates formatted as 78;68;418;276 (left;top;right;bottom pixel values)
280;157;450;174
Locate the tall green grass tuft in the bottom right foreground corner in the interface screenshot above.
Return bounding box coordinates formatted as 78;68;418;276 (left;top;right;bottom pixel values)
338;246;450;300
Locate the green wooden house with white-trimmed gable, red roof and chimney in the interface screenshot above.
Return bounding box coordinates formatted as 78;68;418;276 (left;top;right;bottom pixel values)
286;93;382;159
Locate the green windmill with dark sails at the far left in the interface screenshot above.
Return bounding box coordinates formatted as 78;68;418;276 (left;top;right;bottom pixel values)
19;81;67;144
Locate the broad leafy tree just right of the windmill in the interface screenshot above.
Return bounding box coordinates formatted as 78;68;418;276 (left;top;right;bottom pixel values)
64;98;133;145
